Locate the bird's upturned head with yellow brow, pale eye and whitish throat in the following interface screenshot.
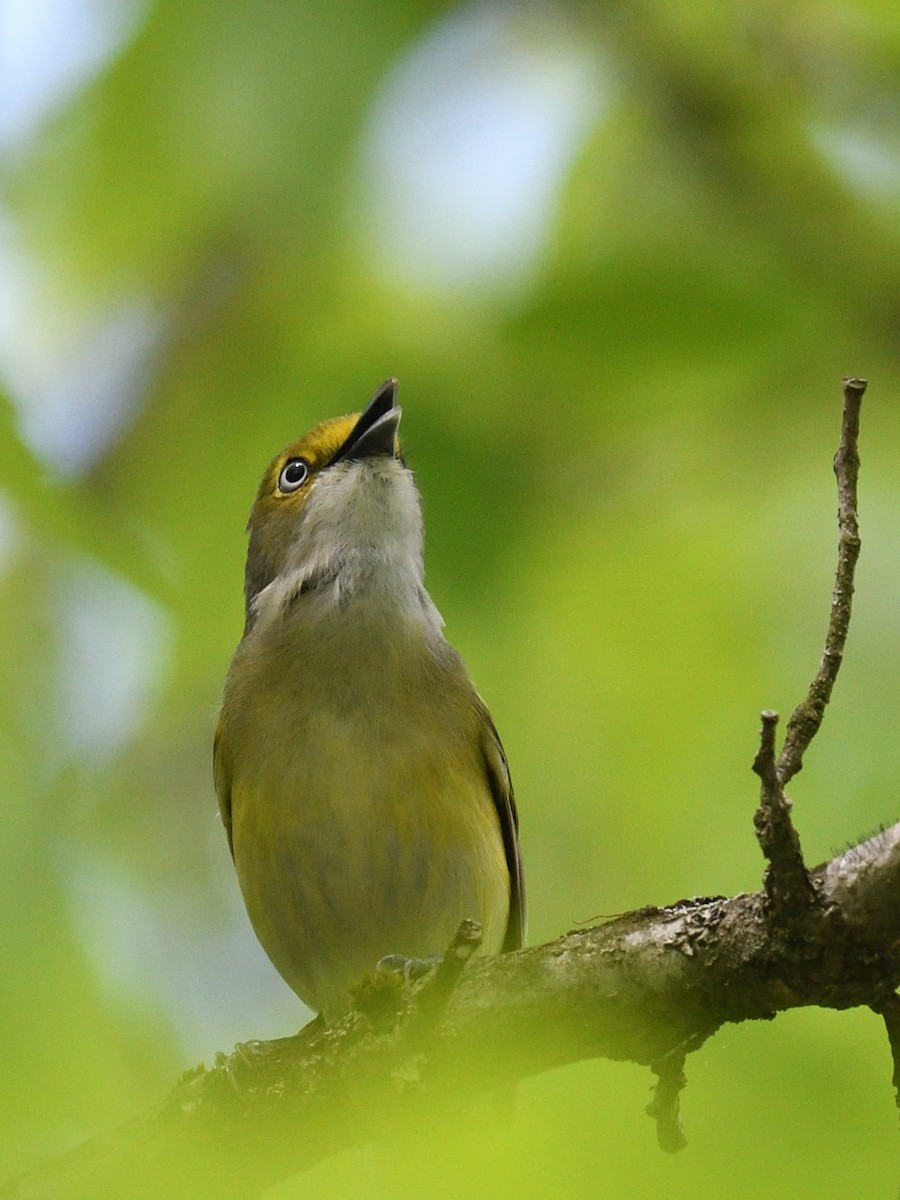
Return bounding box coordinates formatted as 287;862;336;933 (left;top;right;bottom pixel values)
245;379;422;628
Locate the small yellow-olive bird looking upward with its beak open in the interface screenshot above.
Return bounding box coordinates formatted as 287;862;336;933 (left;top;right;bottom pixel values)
214;379;526;1025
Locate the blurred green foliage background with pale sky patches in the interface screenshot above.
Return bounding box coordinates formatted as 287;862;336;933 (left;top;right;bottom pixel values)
0;0;900;1200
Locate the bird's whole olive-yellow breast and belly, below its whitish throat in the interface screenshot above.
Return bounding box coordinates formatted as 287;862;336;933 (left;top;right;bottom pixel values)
222;606;509;1015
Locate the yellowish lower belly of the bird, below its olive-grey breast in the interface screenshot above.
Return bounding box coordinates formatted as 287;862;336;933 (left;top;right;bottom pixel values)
232;722;509;1020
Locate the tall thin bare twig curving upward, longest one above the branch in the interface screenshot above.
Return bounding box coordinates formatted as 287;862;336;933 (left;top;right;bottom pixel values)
778;378;866;785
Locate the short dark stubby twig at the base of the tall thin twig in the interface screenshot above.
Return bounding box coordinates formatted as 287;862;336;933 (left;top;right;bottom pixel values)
754;709;816;922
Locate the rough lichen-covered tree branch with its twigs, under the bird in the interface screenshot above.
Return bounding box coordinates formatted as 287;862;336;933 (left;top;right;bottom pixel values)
0;379;900;1200
